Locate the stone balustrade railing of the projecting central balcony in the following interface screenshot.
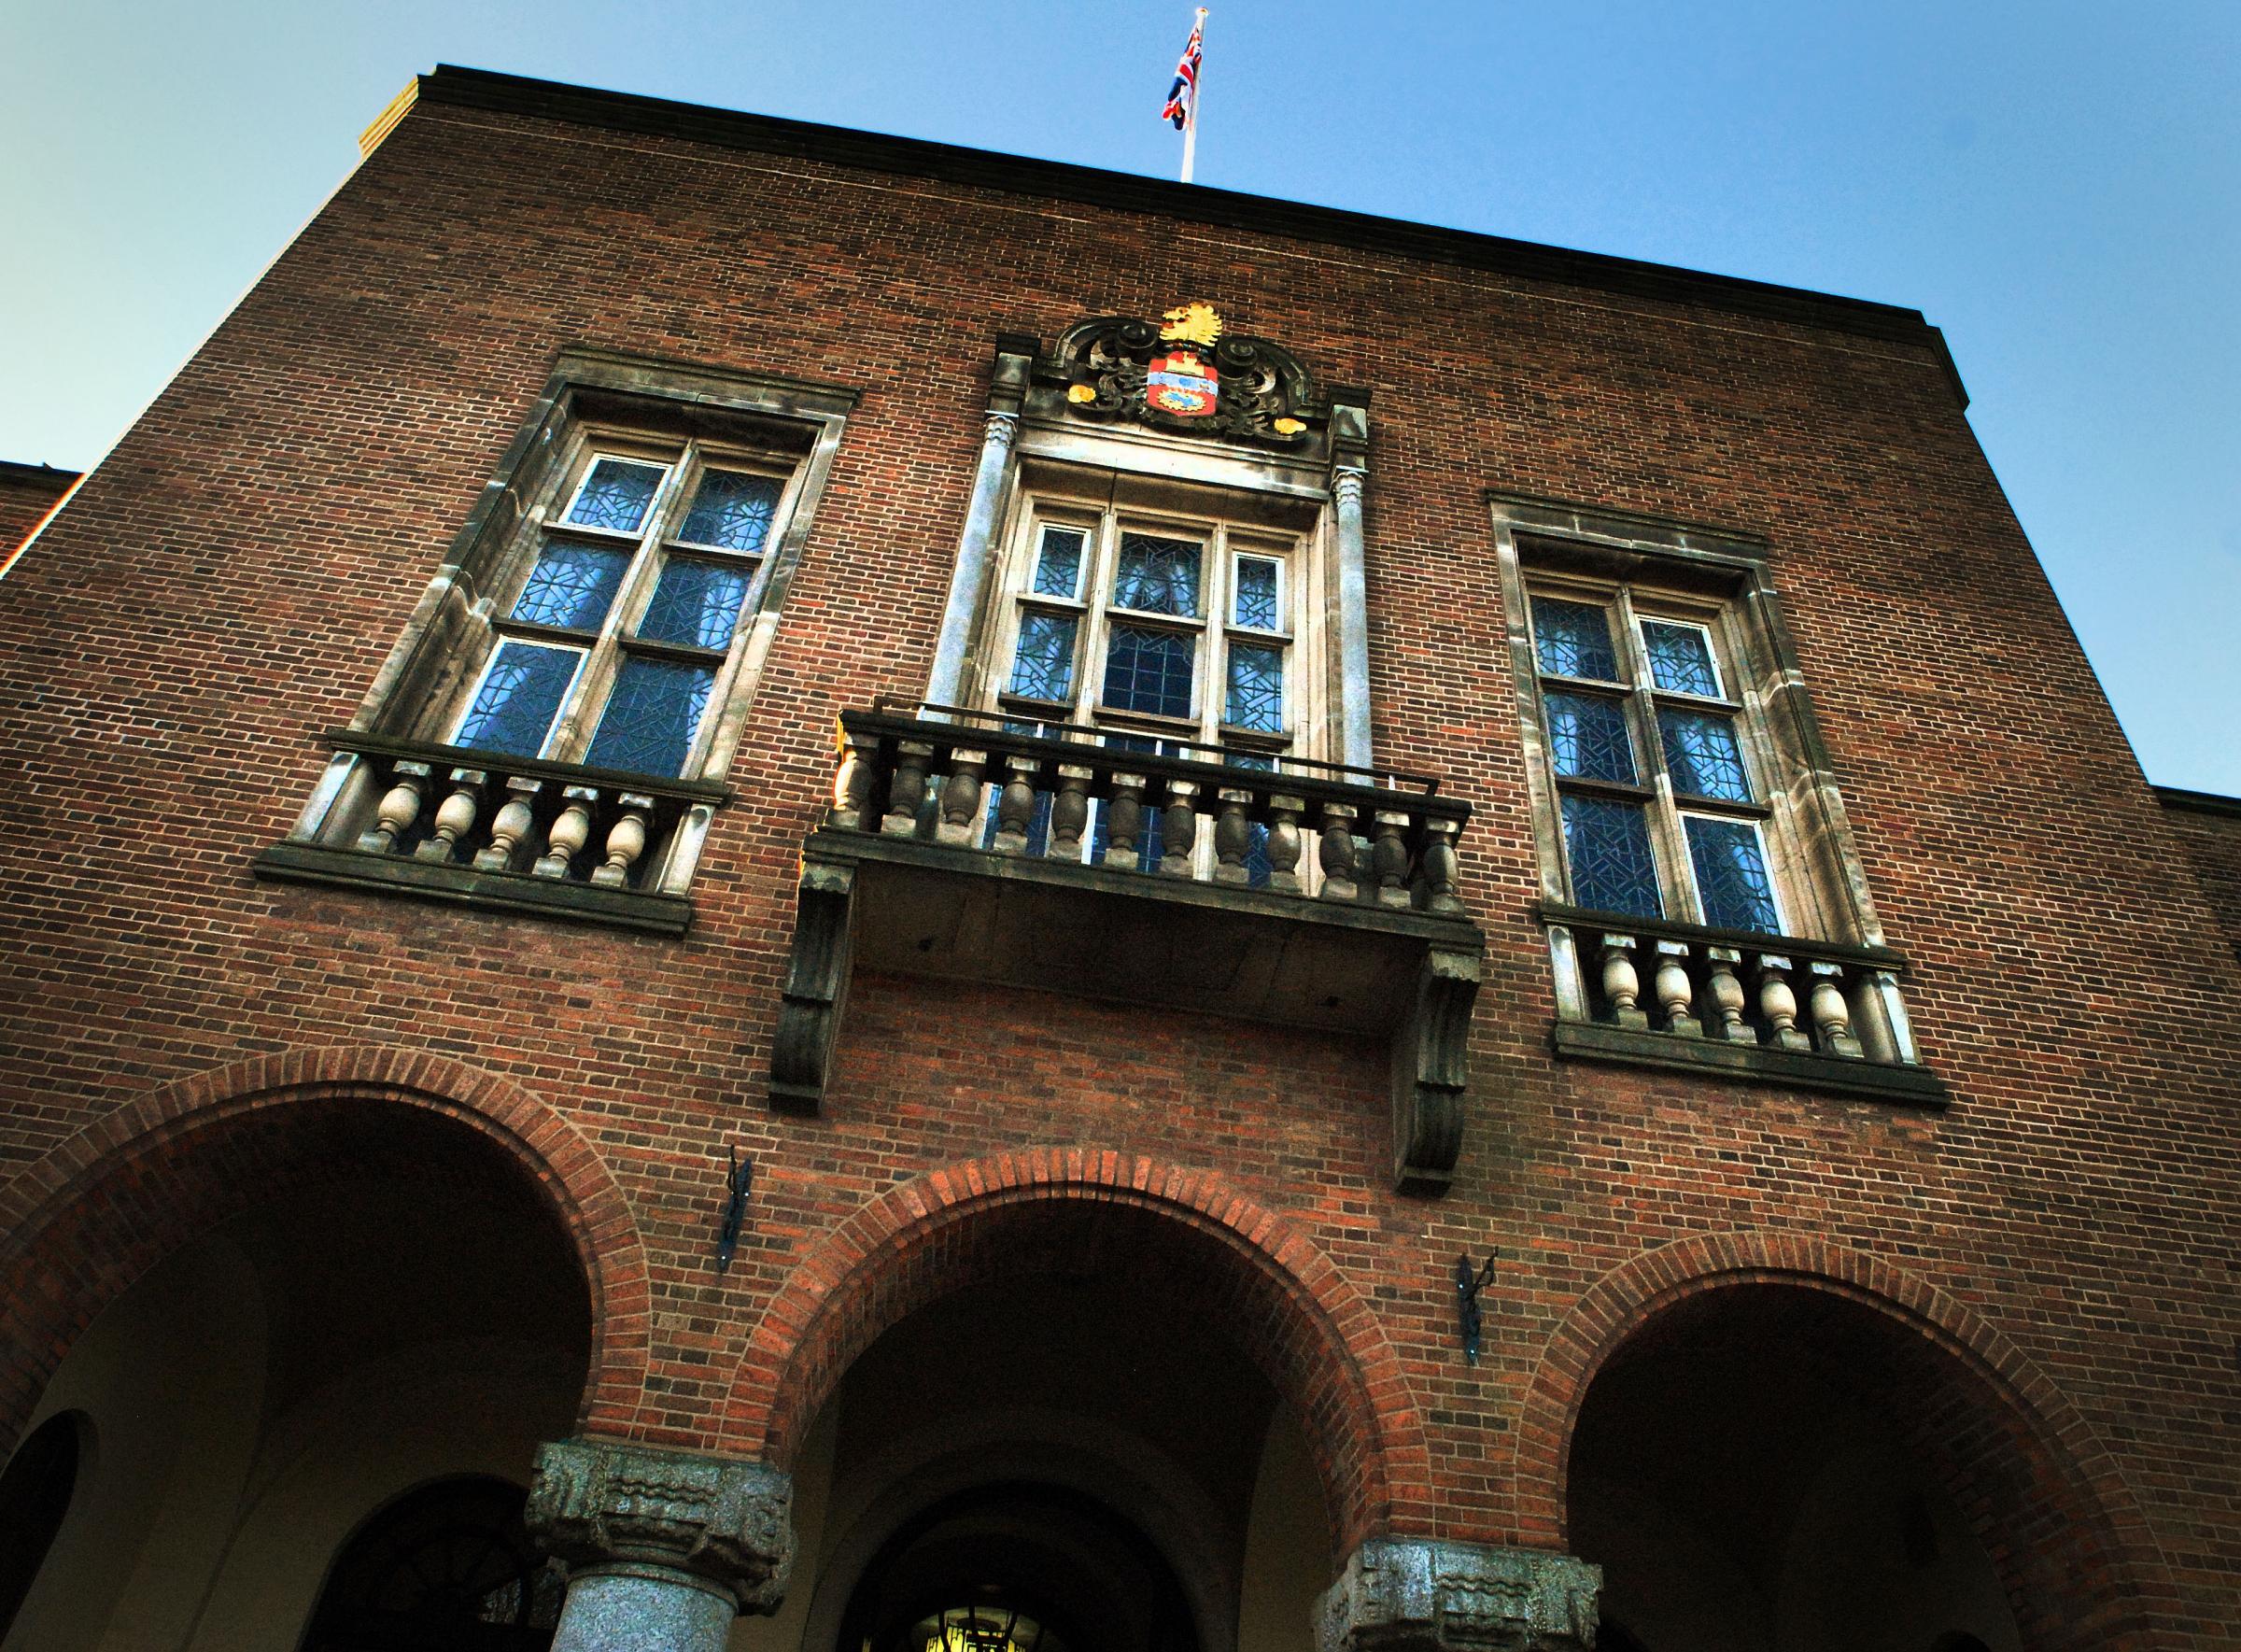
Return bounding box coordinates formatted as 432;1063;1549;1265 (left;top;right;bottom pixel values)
825;701;1470;917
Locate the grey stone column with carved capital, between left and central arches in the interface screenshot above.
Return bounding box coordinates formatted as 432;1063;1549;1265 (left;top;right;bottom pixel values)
527;1439;794;1652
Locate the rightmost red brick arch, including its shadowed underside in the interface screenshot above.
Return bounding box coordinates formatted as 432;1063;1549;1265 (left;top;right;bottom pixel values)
1513;1233;2176;1647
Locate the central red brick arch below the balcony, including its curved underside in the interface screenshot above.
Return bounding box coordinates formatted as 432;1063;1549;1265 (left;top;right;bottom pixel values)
724;1150;1432;1551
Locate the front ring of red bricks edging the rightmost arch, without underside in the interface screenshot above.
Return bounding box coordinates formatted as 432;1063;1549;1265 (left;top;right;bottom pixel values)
1513;1233;2176;1645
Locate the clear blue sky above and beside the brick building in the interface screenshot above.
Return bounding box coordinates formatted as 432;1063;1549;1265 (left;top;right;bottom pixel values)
0;0;2241;794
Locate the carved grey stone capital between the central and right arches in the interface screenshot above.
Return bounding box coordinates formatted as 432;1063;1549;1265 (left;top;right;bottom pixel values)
1316;1538;1602;1652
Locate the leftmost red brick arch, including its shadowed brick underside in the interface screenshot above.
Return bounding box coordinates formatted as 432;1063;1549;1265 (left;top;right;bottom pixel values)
0;1047;650;1457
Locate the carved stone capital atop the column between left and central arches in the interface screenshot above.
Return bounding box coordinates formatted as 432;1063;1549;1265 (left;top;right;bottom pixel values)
525;1439;794;1612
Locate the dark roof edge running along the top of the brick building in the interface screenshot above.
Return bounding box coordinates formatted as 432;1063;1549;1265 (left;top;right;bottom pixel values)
412;63;1967;408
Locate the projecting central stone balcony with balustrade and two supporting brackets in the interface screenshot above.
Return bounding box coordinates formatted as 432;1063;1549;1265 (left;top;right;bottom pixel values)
771;701;1484;1193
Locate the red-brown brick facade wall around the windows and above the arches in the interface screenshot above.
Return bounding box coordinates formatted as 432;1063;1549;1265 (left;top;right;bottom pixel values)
0;84;2241;1645
